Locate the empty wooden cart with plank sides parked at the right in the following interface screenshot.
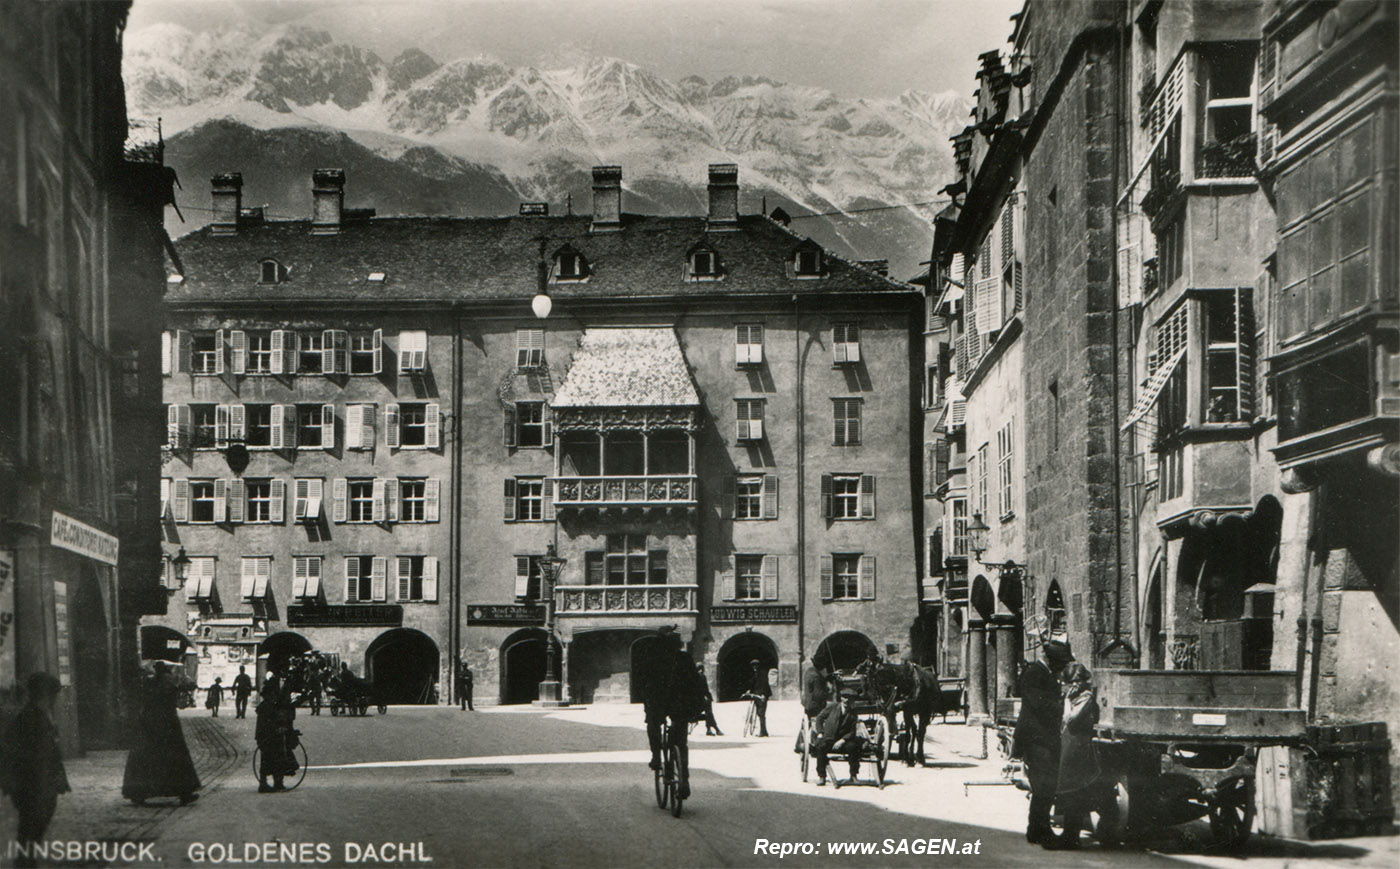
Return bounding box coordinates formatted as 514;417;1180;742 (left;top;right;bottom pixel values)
1095;670;1306;849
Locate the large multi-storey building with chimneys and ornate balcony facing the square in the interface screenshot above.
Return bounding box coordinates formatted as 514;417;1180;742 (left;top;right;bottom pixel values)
147;165;923;702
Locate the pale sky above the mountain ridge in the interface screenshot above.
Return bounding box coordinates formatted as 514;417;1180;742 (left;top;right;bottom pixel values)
127;0;1022;98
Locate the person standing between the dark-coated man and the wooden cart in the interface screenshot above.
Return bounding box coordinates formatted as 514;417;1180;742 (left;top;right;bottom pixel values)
1043;662;1099;851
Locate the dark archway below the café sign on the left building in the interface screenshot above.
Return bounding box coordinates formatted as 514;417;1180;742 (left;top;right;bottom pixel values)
69;560;116;749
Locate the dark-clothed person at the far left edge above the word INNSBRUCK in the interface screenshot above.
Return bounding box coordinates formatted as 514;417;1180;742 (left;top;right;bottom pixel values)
0;673;69;866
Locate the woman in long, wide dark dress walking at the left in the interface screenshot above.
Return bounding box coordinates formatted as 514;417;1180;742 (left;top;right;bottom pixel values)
122;662;202;805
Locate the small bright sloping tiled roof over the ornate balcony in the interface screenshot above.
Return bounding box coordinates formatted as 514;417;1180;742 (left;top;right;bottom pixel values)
550;326;700;407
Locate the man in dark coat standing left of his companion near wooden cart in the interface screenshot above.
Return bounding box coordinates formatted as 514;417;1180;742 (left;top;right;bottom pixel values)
1011;641;1071;844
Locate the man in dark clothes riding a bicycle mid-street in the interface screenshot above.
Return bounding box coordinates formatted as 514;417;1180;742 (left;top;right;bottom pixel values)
637;624;704;799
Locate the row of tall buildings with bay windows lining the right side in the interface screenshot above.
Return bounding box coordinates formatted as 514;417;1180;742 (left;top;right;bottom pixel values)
930;0;1400;834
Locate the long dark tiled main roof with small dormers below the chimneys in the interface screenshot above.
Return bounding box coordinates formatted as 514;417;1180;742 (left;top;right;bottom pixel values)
167;214;911;302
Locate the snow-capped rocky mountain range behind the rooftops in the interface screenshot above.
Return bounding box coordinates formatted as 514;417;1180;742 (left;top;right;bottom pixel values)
125;24;967;277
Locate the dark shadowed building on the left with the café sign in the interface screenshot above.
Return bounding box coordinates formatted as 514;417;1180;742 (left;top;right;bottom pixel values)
0;3;171;751
